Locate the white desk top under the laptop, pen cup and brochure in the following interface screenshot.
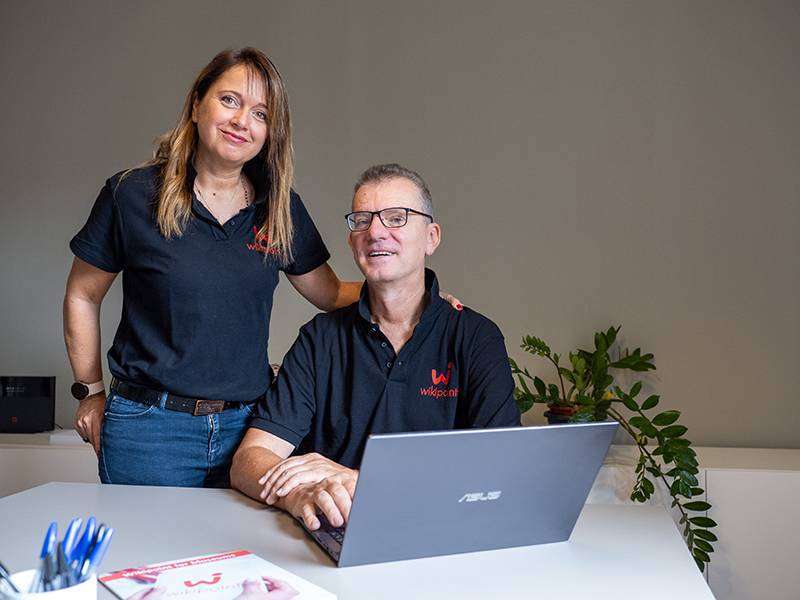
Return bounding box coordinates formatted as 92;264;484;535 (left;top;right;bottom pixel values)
0;483;713;600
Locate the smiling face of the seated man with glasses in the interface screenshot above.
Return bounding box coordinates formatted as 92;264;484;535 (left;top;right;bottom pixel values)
348;177;441;283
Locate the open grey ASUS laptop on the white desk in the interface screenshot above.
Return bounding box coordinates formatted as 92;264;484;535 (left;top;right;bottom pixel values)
300;421;618;567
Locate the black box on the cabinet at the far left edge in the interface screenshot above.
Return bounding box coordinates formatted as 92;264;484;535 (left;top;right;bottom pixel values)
0;377;56;433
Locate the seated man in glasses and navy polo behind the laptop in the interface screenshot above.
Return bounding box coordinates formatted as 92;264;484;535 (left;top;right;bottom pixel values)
231;164;520;530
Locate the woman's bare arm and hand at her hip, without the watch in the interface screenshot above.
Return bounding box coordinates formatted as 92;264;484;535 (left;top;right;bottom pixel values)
64;258;117;452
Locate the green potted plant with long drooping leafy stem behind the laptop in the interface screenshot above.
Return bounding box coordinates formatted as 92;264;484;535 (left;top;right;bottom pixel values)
509;327;717;571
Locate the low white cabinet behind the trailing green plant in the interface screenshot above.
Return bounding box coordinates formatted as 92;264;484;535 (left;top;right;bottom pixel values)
587;446;800;600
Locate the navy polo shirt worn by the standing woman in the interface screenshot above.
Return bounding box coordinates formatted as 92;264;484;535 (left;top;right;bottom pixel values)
70;161;330;401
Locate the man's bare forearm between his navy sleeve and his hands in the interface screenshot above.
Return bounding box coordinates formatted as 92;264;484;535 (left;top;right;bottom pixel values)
231;427;294;508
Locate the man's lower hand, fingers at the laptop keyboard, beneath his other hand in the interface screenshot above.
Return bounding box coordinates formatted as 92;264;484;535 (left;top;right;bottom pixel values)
281;475;356;531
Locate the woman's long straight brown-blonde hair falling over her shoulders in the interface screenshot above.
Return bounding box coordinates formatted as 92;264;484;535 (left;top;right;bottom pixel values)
148;47;294;263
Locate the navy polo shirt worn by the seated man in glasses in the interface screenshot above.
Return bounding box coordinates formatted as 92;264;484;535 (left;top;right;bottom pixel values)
250;269;520;468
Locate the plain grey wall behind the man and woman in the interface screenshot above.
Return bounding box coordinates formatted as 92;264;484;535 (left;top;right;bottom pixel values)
0;0;800;448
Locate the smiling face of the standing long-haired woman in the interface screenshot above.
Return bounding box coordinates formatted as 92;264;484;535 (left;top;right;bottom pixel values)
192;65;267;167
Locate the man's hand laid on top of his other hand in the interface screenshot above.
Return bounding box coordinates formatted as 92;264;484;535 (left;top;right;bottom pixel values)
258;452;358;504
